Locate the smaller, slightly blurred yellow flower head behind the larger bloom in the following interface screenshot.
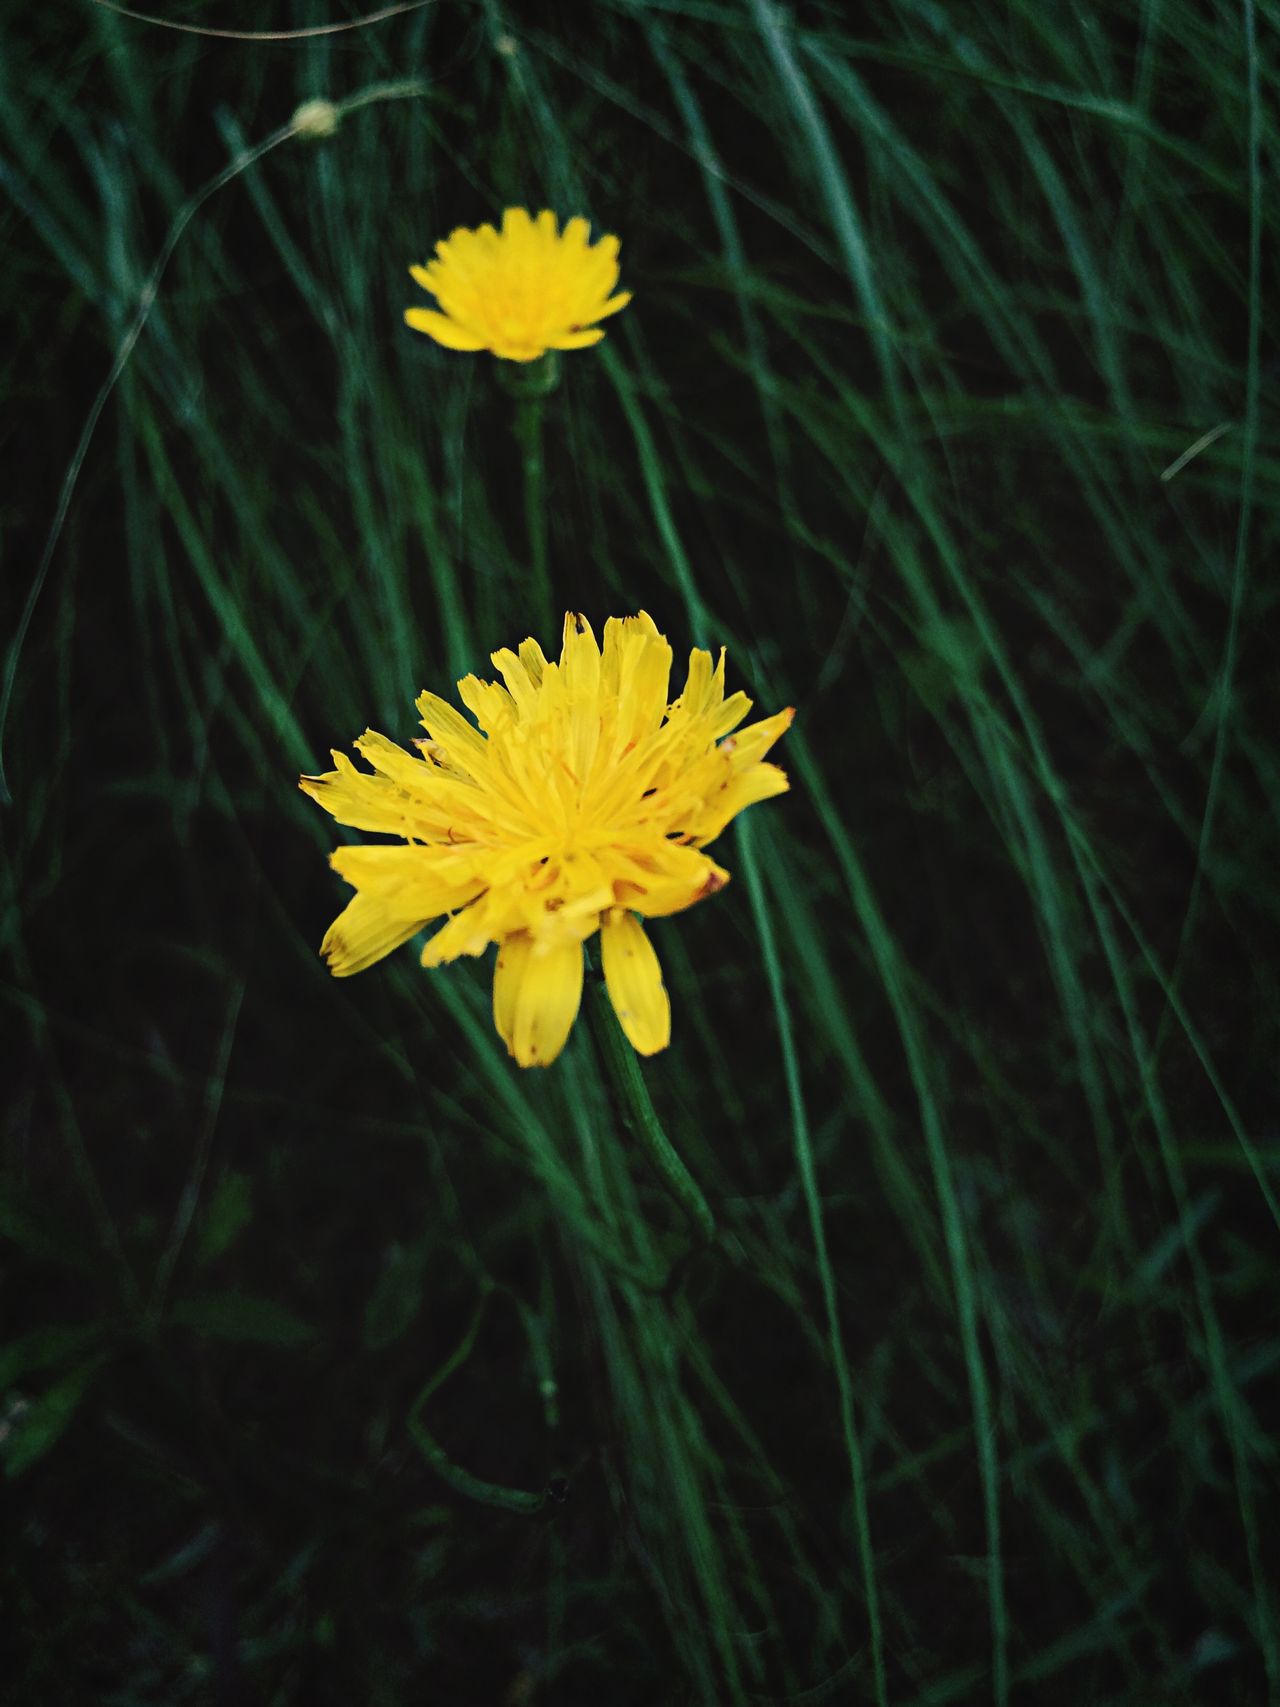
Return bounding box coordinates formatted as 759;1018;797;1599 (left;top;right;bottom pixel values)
404;208;631;362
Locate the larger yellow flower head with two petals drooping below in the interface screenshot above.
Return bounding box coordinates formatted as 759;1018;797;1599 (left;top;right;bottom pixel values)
300;611;794;1067
